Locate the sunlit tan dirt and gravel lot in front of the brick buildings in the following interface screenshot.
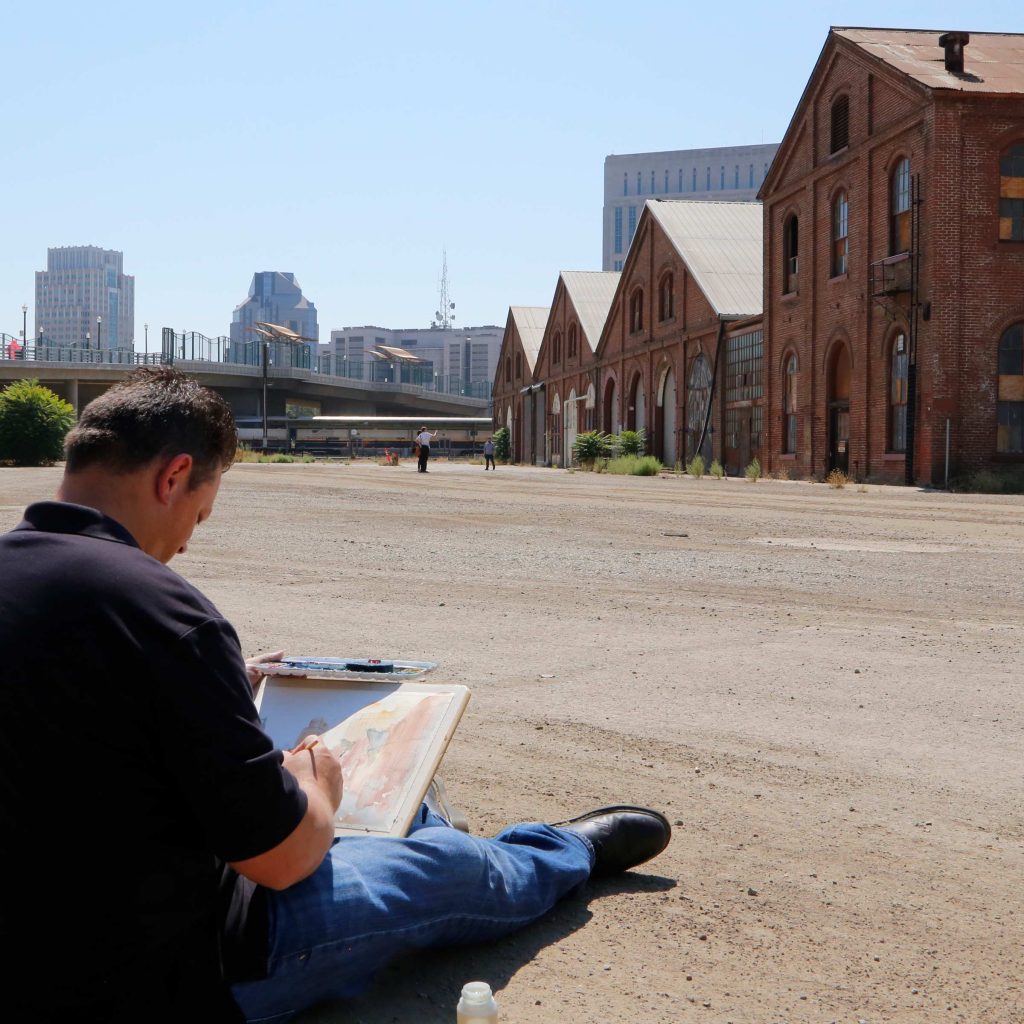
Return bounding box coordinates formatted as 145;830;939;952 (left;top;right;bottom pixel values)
0;463;1024;1024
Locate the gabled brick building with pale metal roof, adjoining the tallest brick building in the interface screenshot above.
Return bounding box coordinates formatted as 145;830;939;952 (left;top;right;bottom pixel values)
595;200;762;472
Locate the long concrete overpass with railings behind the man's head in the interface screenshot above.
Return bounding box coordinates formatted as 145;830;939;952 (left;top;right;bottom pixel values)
0;351;490;417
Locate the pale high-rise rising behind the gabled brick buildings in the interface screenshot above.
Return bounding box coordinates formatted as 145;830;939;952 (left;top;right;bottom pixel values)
601;142;778;270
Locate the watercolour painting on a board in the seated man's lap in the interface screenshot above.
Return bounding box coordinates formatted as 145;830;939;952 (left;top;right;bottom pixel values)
256;676;469;836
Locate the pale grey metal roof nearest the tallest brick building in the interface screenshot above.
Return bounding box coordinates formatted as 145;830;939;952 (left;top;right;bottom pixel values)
646;199;764;317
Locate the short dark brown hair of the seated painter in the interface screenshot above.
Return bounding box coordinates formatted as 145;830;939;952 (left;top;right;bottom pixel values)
65;367;238;486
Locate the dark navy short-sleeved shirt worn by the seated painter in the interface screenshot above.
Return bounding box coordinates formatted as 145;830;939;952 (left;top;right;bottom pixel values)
0;502;306;1021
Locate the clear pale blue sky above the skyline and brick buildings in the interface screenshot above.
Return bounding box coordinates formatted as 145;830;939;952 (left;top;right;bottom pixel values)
0;0;1024;347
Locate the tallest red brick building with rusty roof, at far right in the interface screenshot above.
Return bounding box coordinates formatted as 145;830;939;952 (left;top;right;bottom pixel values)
761;29;1024;482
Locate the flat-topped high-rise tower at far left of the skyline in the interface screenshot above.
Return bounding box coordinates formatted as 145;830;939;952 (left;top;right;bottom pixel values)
36;246;135;350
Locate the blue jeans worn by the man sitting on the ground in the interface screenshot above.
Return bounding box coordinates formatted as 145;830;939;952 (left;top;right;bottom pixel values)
232;806;594;1024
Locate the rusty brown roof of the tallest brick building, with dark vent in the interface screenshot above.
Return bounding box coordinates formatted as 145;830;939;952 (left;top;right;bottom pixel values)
831;28;1024;93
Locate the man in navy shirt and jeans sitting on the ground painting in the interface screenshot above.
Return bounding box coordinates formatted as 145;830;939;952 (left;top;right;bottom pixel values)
0;369;670;1022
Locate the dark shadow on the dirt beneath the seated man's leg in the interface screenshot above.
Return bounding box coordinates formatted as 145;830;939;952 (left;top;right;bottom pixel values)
295;871;678;1024
